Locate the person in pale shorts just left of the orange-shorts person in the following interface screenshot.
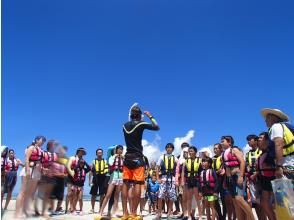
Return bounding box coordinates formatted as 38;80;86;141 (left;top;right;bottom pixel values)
95;145;124;219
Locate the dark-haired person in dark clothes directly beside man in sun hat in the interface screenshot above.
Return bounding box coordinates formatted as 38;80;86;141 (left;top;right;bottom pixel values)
256;132;276;220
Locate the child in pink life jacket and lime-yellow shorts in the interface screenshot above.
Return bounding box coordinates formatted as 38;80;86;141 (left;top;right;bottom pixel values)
199;158;218;220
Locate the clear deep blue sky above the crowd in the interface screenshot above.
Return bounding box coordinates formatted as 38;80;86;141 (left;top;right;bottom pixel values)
1;0;294;167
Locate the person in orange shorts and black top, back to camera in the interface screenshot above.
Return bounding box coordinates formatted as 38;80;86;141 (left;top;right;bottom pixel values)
122;106;159;219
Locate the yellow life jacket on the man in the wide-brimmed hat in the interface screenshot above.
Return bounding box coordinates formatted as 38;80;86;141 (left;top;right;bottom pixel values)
269;123;294;157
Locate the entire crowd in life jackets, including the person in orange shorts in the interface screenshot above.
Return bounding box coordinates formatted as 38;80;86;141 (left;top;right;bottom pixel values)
1;106;294;220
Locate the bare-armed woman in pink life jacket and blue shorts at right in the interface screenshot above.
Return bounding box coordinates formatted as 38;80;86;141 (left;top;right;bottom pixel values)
221;135;254;220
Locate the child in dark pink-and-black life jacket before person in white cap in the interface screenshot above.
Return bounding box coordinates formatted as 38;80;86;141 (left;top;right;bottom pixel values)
72;159;91;215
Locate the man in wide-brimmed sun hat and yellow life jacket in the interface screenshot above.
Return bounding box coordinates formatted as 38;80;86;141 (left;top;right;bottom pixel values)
261;108;294;180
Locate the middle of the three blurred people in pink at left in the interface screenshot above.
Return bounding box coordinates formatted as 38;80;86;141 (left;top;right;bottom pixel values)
35;140;59;217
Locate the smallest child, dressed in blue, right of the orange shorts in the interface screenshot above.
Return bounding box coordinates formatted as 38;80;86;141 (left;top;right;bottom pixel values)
147;175;159;213
